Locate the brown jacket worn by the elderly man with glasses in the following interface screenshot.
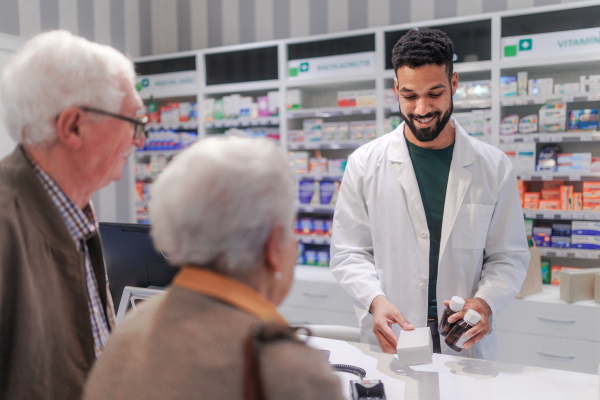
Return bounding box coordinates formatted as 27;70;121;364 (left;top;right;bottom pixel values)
0;147;114;400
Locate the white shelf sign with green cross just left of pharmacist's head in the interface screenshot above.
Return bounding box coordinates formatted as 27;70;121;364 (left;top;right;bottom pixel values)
288;51;375;79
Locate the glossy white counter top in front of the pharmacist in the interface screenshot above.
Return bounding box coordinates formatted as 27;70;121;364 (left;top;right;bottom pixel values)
308;337;600;400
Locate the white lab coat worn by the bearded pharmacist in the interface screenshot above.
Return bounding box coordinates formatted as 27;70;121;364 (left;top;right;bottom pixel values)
330;118;529;360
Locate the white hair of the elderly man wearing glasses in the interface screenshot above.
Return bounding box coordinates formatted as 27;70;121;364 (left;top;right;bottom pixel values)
0;30;135;146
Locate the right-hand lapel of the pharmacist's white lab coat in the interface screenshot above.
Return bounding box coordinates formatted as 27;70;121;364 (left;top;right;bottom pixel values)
439;122;475;261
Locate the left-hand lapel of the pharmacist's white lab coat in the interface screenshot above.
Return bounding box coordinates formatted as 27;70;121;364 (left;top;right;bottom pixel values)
388;122;427;221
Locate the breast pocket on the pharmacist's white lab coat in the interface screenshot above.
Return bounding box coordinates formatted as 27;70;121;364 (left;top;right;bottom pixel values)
452;204;494;249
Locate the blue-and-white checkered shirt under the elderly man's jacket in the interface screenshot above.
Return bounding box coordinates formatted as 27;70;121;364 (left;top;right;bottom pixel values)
23;150;110;358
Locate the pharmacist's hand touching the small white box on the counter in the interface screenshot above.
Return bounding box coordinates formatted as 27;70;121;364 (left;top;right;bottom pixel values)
371;296;415;354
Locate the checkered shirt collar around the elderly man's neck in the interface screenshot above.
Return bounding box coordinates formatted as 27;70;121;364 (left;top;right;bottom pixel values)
21;146;97;245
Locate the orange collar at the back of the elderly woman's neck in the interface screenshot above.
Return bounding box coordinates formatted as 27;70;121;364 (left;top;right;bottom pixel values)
173;265;287;325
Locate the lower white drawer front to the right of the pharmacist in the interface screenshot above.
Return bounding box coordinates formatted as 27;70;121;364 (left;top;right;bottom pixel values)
497;330;600;374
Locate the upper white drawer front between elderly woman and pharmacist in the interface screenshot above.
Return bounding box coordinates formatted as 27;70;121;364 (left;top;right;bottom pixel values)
283;280;354;315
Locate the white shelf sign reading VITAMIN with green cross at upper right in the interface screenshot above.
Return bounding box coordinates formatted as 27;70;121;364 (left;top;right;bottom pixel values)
502;28;600;60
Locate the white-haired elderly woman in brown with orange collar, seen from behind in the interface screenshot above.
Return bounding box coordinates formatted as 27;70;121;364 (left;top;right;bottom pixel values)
84;138;342;400
